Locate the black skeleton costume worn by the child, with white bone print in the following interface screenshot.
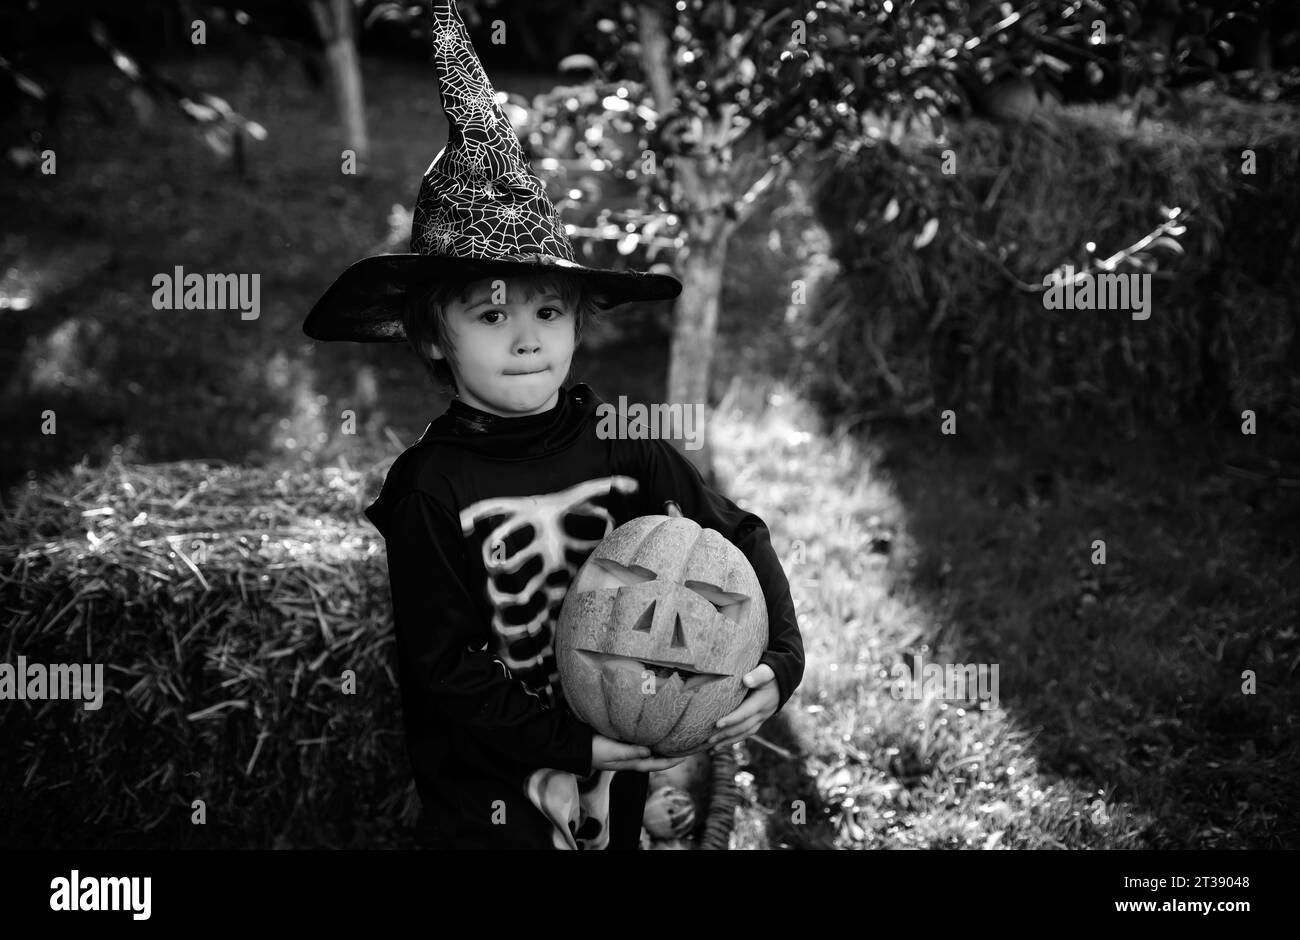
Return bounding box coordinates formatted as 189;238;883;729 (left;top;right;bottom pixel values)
365;385;803;848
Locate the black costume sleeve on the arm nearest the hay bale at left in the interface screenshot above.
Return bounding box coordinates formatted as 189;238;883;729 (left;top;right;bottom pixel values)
386;491;594;775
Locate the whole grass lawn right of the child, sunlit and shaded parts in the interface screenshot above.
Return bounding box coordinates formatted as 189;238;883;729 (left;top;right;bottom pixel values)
714;391;1300;849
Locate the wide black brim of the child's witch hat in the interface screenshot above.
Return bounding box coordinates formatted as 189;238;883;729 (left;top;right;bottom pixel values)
303;255;681;343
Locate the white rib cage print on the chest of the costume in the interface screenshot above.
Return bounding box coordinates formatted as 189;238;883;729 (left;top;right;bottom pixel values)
460;476;638;705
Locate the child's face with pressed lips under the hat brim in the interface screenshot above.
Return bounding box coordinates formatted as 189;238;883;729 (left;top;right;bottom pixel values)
430;277;576;417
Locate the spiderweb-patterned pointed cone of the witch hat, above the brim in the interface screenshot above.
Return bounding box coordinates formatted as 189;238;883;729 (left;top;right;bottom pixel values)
411;3;573;263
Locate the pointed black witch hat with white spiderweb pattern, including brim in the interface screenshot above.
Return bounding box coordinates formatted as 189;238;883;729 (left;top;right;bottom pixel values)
303;0;681;343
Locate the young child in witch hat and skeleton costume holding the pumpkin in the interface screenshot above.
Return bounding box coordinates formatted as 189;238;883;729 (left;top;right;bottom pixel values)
304;4;803;849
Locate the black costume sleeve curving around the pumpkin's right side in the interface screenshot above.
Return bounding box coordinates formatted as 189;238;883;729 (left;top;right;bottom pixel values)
638;438;803;709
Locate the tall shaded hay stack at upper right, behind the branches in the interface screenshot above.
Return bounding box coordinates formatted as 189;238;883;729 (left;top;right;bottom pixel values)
800;88;1300;426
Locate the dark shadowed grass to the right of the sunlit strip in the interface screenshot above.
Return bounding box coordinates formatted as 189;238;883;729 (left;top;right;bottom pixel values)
874;419;1300;848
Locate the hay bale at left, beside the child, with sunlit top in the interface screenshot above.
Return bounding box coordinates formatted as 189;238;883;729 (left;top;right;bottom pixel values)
0;462;417;848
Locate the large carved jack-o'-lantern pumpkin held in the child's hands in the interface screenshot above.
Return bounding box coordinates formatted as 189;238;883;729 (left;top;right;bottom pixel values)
555;516;767;757
